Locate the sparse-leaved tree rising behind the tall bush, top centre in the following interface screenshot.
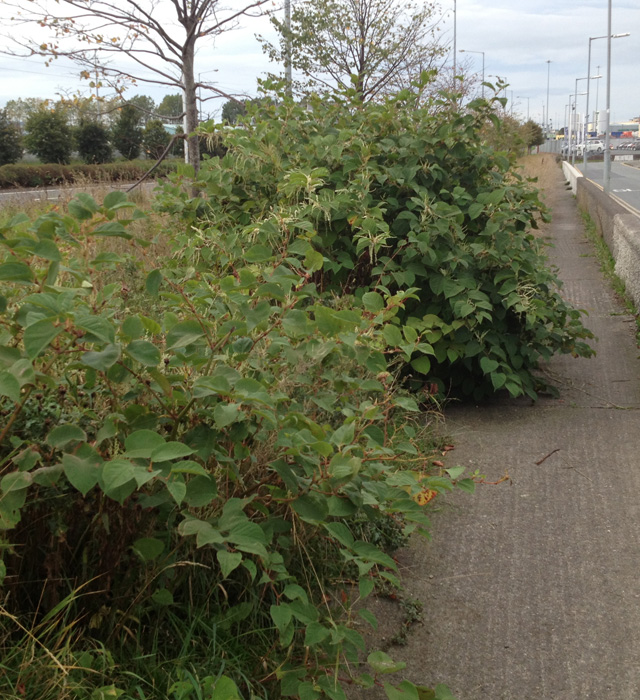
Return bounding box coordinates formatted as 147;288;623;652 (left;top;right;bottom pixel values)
262;0;443;101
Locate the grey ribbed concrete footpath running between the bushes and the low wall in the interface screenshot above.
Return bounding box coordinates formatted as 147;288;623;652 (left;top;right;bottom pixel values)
352;160;640;700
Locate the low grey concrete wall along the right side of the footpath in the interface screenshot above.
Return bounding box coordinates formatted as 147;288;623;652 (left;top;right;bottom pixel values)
576;174;640;309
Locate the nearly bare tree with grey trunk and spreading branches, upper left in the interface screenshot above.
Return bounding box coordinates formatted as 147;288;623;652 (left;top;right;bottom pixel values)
3;0;270;169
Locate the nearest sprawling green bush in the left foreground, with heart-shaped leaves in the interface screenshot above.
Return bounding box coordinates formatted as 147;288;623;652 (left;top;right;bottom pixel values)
0;182;464;700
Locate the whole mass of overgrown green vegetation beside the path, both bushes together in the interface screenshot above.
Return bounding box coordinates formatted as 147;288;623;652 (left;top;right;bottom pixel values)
0;78;589;700
